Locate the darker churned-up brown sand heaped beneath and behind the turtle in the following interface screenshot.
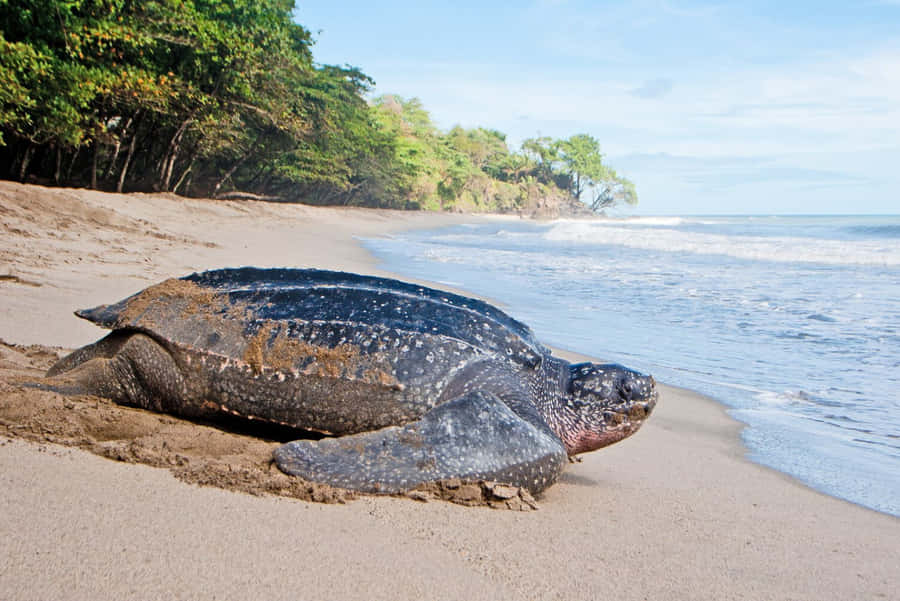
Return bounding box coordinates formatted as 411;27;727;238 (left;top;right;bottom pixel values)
0;340;537;510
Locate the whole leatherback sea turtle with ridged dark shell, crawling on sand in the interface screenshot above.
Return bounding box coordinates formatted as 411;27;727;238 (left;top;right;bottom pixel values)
47;267;657;493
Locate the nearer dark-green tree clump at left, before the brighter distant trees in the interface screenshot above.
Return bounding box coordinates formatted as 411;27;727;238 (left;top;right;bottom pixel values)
0;0;392;201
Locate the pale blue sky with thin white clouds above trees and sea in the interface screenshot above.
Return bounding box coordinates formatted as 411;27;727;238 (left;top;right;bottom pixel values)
296;0;900;214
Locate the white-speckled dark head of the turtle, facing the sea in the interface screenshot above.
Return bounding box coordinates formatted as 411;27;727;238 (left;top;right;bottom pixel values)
553;363;658;455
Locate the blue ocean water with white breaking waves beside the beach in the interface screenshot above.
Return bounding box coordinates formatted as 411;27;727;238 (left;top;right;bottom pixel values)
365;216;900;516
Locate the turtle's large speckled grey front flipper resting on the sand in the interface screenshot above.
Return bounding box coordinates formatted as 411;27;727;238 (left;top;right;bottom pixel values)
275;391;567;493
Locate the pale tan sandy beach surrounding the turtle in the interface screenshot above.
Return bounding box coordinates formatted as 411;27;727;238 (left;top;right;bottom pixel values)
0;182;900;600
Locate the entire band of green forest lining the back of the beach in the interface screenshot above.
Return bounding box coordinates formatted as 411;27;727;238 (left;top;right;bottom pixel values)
0;0;637;212
